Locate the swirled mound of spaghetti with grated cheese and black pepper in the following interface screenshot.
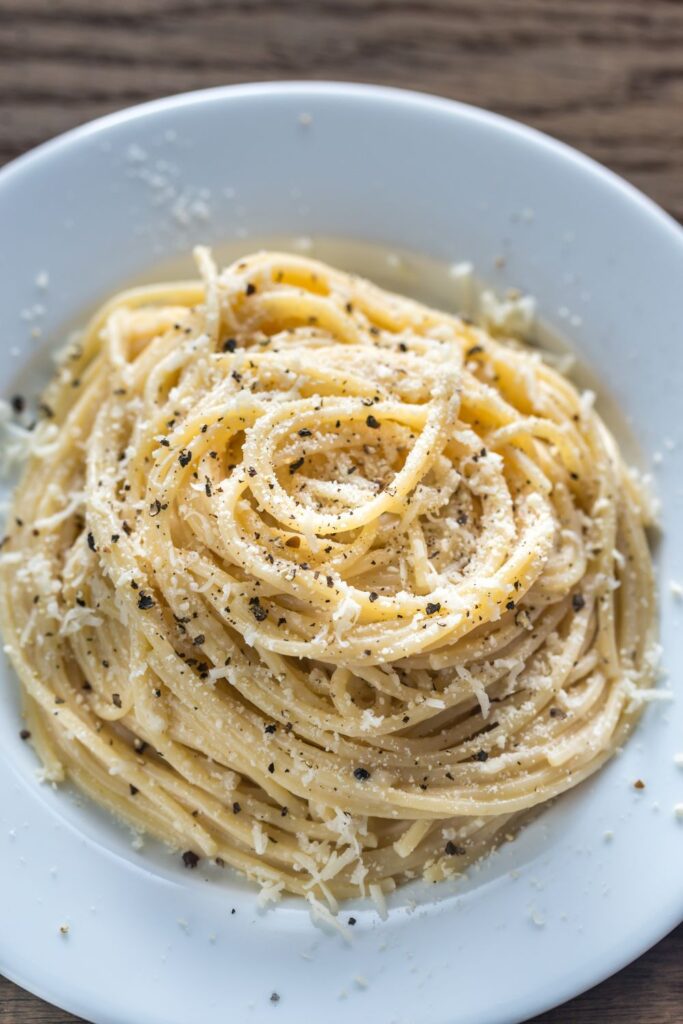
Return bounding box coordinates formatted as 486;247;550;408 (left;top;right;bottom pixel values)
1;250;653;909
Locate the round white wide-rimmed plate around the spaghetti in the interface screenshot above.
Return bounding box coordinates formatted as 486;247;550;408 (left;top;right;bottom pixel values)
0;83;683;1024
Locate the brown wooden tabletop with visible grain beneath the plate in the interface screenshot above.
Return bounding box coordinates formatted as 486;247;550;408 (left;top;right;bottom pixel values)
0;0;683;1024
